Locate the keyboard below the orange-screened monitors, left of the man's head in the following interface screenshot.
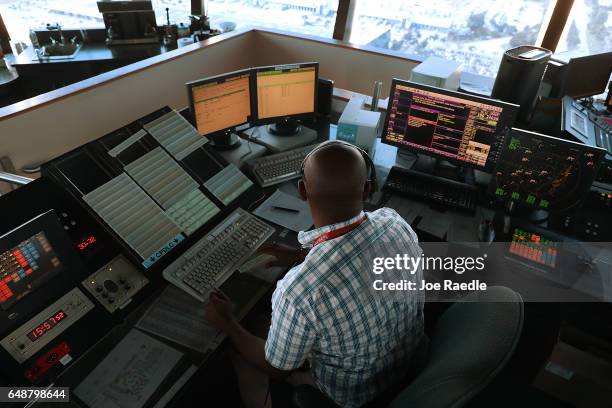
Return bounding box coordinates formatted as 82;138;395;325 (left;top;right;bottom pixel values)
247;143;318;187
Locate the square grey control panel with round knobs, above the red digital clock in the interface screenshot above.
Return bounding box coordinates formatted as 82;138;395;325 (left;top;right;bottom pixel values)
83;255;149;313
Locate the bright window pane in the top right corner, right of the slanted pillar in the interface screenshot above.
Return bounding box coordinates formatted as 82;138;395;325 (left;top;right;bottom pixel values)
556;0;612;57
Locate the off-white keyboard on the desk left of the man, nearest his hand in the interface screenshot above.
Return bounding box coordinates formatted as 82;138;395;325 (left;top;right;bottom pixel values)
163;208;274;302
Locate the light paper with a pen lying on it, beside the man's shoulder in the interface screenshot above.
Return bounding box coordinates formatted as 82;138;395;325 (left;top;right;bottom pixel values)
253;190;313;232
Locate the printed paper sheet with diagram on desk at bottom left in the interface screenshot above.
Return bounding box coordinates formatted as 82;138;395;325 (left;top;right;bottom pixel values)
74;330;182;408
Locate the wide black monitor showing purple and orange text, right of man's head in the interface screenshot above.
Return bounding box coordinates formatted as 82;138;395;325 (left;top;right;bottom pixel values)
382;79;519;171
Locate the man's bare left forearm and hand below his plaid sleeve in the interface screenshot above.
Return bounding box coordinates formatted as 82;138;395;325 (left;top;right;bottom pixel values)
206;291;291;378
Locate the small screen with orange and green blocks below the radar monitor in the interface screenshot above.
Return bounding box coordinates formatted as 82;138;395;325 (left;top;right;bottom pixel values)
510;228;559;268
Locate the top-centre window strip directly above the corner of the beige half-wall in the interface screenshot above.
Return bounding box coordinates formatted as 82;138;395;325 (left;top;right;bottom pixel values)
208;0;338;38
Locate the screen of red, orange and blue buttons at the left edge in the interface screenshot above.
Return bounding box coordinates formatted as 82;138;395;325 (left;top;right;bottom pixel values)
0;232;61;309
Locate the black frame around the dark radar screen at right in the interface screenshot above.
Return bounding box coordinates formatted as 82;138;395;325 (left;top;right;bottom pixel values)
487;127;606;213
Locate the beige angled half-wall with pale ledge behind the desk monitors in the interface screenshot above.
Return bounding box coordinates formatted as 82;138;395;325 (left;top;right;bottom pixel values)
0;29;418;175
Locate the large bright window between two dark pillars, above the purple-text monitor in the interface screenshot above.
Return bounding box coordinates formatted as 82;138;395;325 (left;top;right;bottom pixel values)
350;0;556;76
